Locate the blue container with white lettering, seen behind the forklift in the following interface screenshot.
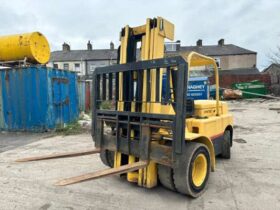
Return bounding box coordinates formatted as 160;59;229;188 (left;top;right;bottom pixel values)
162;74;209;100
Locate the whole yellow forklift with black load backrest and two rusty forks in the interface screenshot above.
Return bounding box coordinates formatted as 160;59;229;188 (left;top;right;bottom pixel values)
18;17;233;197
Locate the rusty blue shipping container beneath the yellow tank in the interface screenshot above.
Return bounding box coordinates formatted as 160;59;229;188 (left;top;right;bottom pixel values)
0;66;79;132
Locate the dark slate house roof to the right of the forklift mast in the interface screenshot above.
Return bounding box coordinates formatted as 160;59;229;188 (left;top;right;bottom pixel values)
180;44;257;56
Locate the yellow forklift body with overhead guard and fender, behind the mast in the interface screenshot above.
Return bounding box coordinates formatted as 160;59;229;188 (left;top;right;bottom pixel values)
160;52;233;171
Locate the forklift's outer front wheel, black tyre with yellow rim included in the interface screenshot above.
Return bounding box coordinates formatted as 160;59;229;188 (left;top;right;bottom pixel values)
174;142;210;198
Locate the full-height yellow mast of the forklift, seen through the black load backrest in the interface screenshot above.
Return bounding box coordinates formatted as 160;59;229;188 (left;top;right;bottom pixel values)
117;17;174;187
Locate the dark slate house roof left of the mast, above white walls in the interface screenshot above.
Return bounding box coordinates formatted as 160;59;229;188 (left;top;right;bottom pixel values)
50;49;118;62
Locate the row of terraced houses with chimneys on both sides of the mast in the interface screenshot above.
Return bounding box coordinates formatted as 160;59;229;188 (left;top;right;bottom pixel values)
48;39;259;78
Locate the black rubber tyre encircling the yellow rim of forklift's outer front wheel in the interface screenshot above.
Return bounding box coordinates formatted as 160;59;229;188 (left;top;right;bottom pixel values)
173;142;210;198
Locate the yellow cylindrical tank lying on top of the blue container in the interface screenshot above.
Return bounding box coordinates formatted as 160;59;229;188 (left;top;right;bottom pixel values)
0;32;50;64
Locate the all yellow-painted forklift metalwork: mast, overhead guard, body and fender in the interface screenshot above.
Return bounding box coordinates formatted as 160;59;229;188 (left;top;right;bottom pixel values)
114;17;233;188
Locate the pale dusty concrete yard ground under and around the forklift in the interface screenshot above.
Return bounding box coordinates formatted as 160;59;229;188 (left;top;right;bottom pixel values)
0;100;280;210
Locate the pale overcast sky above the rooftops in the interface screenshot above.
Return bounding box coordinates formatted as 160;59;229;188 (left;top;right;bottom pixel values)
0;0;280;70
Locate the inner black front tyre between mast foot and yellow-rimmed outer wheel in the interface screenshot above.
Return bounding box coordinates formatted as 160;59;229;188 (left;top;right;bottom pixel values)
158;164;176;191
